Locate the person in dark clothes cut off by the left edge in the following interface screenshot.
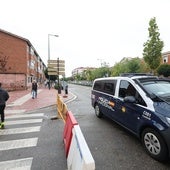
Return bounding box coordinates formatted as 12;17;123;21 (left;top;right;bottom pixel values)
0;83;9;129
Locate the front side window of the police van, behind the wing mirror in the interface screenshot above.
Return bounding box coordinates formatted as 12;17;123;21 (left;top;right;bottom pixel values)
119;80;146;106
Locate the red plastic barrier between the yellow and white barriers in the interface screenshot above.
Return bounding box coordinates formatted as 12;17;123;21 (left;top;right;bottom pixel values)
63;111;78;157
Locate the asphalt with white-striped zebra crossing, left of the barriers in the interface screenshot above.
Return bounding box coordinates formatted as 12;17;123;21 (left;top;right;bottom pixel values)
0;106;67;170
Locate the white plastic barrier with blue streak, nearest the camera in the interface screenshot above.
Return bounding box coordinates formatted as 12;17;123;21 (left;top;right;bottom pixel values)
67;125;95;170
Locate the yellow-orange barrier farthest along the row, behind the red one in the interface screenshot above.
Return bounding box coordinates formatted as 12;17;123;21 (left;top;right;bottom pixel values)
57;95;68;122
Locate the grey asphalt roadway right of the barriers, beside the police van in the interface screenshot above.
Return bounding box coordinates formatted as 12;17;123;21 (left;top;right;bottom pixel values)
67;85;170;170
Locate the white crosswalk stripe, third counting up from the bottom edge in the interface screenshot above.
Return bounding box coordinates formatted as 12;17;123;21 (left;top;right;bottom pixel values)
0;126;41;135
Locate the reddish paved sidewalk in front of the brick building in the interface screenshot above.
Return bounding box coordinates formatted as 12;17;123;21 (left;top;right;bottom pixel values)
5;88;73;113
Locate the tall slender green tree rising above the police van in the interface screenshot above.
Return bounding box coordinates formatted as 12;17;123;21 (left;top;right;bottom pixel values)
143;17;164;72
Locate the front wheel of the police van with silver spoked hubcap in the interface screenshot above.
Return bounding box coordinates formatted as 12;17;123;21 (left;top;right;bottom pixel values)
142;128;168;161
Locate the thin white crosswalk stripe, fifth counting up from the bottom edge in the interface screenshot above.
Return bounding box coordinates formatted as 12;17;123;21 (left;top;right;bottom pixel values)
5;113;44;119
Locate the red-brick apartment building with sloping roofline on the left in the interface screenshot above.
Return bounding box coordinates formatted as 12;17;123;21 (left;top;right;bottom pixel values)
0;29;46;90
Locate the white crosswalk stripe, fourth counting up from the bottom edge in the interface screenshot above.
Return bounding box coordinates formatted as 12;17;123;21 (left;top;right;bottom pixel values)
5;119;43;125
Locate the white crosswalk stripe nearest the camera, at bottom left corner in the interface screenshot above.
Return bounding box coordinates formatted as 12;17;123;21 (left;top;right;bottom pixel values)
0;158;33;170
